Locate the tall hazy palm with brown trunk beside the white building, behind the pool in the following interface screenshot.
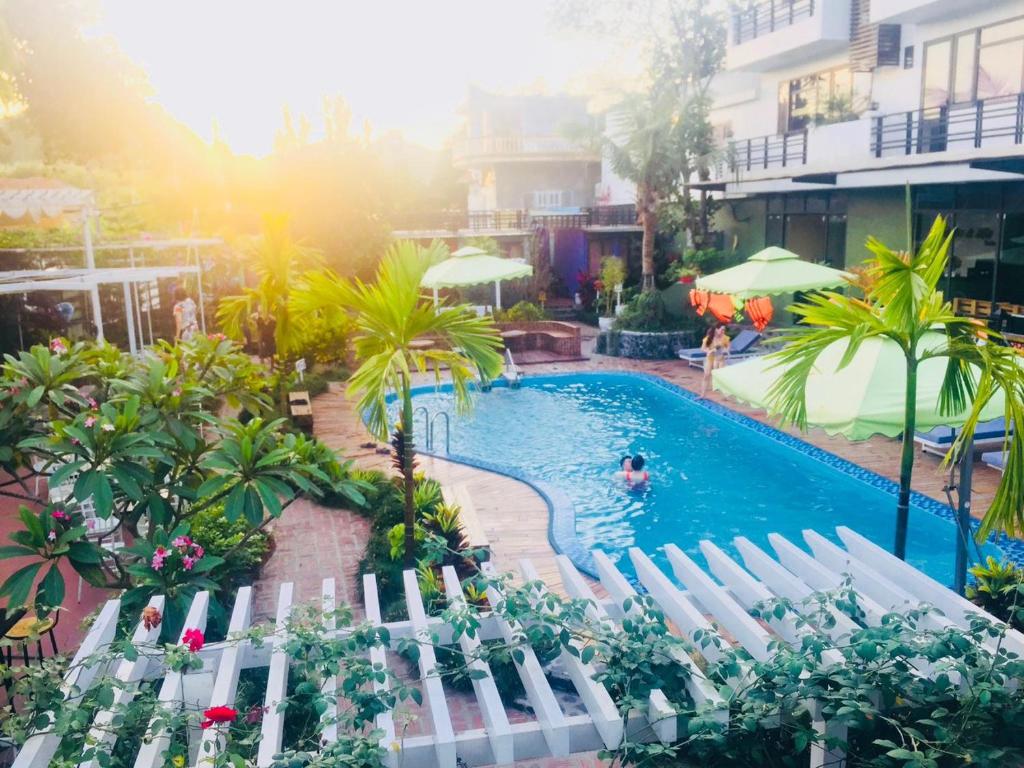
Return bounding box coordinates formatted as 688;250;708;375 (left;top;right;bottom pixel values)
602;88;683;291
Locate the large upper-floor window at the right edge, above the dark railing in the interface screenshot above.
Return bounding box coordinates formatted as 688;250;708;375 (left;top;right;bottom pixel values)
922;16;1024;108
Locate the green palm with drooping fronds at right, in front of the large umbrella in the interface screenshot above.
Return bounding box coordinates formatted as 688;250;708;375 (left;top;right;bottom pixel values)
769;216;1024;558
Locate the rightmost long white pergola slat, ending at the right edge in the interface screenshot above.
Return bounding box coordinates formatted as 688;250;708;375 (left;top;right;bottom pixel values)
836;525;1024;656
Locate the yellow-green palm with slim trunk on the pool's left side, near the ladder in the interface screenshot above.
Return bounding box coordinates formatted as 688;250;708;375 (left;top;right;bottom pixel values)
293;241;502;565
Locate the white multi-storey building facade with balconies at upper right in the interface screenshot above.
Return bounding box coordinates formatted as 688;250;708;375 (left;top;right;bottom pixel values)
710;0;1024;315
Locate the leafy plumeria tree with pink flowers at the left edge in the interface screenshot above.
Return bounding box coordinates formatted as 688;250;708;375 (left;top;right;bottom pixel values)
0;335;361;631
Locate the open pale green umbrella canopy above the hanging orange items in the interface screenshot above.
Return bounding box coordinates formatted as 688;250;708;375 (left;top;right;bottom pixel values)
696;246;851;299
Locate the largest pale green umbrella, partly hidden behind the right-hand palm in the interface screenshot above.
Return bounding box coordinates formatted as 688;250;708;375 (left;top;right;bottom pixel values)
712;333;1005;589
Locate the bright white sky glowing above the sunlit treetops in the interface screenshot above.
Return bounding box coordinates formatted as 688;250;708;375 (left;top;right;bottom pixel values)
97;0;624;155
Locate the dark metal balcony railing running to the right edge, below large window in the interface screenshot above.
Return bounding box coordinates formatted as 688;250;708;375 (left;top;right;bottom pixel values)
871;93;1024;158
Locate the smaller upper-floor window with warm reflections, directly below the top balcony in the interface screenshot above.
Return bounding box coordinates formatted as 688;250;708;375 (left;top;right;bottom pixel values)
778;67;857;133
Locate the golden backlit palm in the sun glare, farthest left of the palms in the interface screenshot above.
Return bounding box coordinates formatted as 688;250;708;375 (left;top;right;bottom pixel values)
217;214;319;365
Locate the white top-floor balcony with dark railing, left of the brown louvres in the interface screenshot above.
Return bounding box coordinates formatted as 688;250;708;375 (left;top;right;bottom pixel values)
726;0;851;72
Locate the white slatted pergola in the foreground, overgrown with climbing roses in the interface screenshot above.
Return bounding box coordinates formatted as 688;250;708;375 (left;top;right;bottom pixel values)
14;527;1024;768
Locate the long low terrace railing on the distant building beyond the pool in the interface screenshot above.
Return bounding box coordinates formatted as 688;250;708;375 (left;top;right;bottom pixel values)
395;204;637;232
